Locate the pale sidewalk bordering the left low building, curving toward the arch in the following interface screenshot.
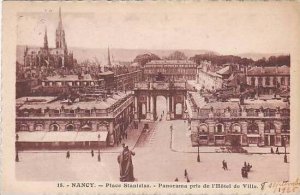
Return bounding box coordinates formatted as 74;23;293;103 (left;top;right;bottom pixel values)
19;121;152;153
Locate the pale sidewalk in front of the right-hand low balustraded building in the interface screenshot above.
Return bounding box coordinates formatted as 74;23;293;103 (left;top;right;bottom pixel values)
171;121;289;154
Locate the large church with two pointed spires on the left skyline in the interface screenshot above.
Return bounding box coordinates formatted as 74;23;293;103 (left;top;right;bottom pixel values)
24;8;74;68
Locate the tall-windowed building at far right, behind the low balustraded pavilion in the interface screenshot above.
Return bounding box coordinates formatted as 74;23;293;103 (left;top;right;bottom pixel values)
246;66;290;95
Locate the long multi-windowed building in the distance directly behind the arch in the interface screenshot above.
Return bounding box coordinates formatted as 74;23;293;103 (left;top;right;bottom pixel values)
144;60;197;81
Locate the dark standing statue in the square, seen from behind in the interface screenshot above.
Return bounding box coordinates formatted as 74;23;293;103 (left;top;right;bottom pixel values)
118;145;135;182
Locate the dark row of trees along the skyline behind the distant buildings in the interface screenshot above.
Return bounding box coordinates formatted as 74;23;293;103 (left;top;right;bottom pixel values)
134;51;290;66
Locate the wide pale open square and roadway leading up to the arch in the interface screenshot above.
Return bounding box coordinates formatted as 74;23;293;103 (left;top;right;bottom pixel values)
16;120;289;182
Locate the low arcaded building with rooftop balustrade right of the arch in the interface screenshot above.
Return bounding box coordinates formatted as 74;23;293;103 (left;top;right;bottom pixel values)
186;92;290;146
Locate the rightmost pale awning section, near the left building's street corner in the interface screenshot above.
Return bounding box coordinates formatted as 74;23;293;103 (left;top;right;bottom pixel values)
75;131;108;142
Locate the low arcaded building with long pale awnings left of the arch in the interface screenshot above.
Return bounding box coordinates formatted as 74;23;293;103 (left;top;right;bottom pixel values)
16;92;134;149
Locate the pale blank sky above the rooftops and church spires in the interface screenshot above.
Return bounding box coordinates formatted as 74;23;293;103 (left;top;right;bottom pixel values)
17;4;299;54
